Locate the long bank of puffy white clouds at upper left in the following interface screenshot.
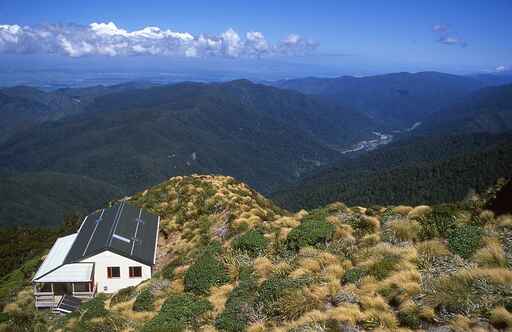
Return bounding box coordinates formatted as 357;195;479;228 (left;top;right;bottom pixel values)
0;22;318;58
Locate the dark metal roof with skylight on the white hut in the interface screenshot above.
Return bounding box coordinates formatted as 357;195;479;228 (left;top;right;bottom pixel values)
64;201;159;265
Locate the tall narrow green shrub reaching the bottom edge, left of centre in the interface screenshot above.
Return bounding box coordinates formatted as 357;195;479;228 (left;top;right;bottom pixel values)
215;269;257;332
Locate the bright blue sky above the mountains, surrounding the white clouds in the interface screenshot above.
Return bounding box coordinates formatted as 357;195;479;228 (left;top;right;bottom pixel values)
0;0;512;76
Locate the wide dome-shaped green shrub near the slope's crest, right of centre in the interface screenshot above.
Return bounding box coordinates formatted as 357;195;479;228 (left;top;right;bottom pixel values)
286;219;335;250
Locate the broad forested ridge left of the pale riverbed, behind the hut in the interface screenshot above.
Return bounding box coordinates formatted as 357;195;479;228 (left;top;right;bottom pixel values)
0;80;377;224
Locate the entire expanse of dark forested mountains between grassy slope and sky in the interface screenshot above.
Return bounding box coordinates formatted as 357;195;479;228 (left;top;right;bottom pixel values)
0;72;512;225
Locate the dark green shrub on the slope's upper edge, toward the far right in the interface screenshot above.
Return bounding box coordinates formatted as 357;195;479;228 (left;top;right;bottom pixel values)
419;205;457;240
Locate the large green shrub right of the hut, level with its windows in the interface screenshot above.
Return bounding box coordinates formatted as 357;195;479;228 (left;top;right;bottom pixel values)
185;244;229;294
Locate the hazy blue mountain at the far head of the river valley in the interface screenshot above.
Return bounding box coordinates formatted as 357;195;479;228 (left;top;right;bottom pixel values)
272;72;504;129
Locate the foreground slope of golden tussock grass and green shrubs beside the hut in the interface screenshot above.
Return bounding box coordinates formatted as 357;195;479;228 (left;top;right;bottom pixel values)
4;176;512;332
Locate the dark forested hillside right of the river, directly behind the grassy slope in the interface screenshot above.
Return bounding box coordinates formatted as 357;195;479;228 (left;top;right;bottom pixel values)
272;135;512;210
